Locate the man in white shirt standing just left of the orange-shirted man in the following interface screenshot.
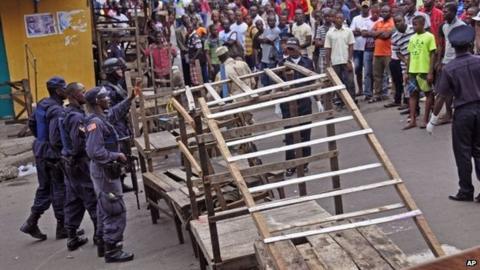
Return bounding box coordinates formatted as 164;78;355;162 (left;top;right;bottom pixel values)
350;1;371;94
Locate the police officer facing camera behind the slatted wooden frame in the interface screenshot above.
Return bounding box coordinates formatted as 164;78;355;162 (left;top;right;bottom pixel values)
279;37;314;177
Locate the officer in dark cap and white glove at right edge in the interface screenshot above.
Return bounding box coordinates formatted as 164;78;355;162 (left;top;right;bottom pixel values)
427;25;480;202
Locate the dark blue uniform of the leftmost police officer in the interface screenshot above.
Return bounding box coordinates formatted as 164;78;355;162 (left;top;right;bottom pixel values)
29;97;65;225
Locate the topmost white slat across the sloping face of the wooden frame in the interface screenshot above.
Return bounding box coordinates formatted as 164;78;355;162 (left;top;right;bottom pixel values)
205;84;345;119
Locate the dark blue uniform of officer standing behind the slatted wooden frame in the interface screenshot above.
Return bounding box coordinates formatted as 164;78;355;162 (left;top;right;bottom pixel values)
280;56;314;160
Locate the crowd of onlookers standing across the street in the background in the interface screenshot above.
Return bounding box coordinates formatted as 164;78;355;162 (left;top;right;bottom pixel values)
124;0;480;129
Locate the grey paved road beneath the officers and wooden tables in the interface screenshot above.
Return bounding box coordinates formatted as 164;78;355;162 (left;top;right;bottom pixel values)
0;99;480;270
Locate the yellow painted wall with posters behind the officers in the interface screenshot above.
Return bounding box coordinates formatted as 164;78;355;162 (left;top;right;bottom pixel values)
0;0;95;106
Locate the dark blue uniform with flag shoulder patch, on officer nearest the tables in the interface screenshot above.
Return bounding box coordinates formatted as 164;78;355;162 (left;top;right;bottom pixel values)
86;99;130;244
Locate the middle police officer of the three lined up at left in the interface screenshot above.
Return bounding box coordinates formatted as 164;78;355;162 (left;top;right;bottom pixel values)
59;82;99;251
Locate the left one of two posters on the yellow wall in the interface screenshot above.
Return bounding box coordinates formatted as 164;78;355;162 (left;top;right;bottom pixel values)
25;13;57;38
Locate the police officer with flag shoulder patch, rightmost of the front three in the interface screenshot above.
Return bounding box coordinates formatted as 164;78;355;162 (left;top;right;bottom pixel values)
85;87;139;263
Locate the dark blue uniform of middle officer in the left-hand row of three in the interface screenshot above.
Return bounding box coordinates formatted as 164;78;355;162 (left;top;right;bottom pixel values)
60;105;97;230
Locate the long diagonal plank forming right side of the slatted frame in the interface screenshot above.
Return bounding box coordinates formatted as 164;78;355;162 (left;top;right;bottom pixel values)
327;68;445;257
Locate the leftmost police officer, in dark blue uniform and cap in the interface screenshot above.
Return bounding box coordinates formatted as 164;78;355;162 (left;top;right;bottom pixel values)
20;76;67;240
